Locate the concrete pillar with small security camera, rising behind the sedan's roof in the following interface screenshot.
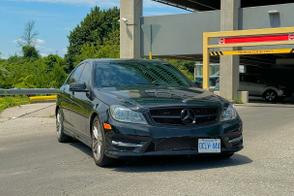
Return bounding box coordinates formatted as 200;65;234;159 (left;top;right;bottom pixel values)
120;0;143;58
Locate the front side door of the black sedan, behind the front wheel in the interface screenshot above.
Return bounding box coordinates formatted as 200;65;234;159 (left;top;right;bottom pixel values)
72;62;93;142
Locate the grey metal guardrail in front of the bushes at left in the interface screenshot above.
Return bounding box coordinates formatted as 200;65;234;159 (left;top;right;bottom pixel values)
0;88;59;96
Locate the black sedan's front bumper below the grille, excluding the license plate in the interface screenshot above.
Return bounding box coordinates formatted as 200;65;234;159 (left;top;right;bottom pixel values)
105;119;243;158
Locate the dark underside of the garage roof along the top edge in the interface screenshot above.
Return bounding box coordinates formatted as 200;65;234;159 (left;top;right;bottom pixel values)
153;0;294;11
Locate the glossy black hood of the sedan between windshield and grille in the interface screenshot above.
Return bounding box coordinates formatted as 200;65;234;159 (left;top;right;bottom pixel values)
95;87;225;108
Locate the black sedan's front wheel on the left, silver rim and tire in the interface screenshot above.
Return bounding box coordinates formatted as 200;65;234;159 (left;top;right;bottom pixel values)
91;117;114;167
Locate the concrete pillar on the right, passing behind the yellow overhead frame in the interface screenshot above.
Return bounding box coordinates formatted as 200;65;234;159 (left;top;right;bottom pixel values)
220;0;241;101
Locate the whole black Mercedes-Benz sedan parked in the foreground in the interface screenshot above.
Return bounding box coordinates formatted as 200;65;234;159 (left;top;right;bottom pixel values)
56;59;243;166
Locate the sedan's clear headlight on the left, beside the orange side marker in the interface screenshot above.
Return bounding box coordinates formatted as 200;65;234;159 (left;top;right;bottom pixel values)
110;105;147;124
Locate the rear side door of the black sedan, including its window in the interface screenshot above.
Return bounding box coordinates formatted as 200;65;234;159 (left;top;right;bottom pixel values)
60;66;84;132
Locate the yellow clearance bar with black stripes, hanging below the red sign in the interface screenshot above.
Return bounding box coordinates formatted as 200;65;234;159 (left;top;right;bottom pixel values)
209;48;294;56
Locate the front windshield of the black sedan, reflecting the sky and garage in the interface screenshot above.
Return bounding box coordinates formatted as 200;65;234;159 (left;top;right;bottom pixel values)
95;61;191;88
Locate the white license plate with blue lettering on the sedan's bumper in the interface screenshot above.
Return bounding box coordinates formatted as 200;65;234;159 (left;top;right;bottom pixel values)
198;139;221;153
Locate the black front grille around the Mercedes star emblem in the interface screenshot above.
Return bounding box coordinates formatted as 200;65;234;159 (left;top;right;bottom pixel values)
150;107;218;125
